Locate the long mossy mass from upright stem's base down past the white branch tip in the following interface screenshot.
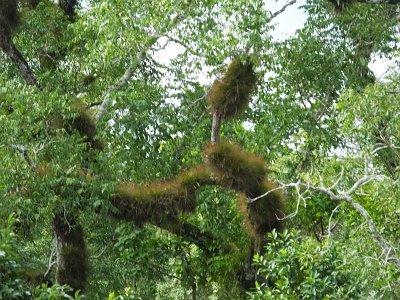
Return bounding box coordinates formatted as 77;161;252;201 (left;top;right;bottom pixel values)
205;142;283;251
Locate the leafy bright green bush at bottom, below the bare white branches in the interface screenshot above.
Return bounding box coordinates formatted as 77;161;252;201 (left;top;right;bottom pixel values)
248;230;360;299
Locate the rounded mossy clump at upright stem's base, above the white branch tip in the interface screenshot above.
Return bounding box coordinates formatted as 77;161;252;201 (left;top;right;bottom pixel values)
205;142;267;194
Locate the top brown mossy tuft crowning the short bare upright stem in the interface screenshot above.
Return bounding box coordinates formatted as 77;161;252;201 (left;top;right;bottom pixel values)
208;58;257;118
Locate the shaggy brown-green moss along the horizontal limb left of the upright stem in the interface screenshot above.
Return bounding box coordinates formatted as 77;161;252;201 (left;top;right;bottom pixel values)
112;165;213;225
